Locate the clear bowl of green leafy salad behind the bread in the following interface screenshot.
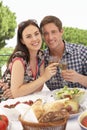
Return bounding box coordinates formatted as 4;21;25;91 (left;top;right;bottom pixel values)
52;86;87;103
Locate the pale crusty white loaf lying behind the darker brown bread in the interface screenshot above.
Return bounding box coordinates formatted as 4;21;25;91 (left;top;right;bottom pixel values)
31;99;68;120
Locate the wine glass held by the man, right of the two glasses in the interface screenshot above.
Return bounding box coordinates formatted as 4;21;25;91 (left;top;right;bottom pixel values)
59;59;68;85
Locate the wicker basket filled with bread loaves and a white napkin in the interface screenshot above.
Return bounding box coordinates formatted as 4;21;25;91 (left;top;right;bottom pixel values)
19;100;69;130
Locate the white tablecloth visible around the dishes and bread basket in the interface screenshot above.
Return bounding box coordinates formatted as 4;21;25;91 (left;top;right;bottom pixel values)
0;85;85;130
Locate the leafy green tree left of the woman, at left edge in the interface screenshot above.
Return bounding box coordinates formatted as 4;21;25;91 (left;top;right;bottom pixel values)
0;1;17;48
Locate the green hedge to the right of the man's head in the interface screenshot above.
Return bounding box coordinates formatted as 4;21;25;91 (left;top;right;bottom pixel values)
63;27;87;46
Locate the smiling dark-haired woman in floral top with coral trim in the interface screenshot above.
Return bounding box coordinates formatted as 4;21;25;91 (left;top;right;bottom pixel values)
2;20;58;98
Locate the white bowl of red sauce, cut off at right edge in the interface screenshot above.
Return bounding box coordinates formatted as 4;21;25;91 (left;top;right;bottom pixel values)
78;110;87;130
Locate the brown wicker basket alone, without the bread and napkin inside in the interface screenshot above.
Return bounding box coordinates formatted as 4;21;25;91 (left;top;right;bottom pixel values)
19;116;68;130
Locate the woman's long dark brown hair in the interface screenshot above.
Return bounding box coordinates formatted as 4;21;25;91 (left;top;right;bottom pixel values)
7;19;41;66
